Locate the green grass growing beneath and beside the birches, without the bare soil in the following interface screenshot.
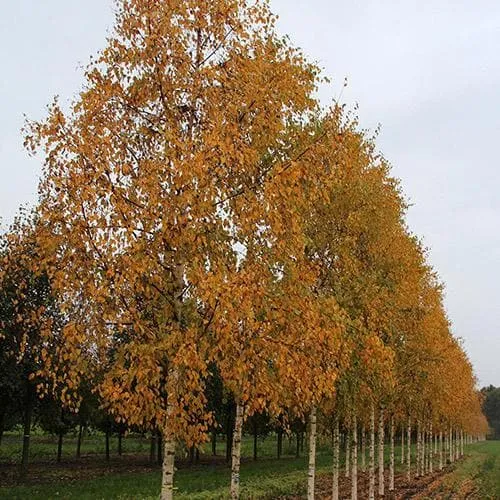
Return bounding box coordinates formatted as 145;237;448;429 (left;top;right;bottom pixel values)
0;434;488;500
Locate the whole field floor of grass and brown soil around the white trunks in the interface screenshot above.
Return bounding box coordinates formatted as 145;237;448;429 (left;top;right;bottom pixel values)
0;434;500;500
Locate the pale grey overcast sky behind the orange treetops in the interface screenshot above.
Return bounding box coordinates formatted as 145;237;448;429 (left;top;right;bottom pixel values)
0;0;500;386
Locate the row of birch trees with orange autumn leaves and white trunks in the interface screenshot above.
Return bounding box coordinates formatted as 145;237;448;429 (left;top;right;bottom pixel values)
3;0;485;499
